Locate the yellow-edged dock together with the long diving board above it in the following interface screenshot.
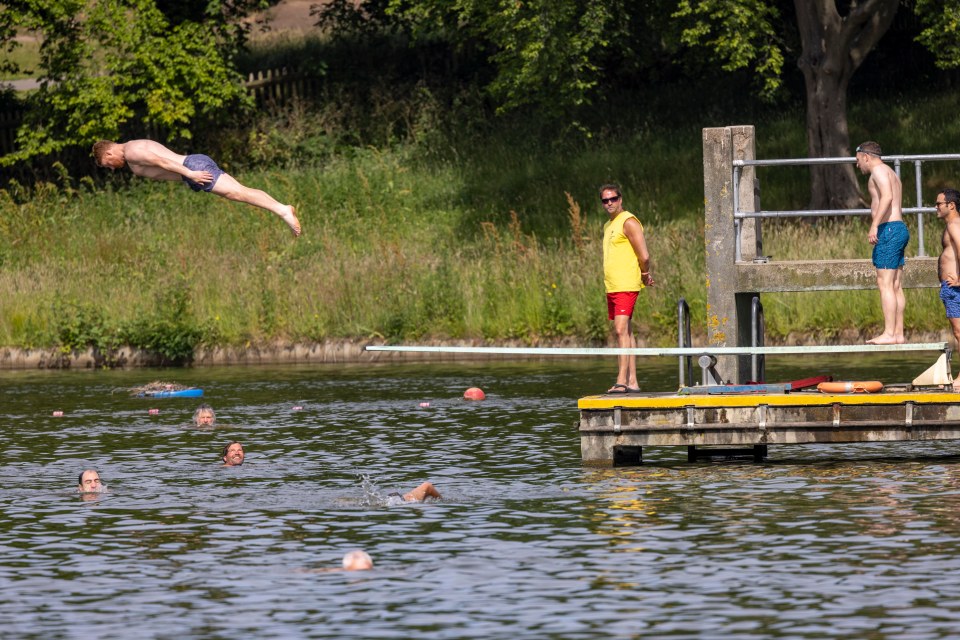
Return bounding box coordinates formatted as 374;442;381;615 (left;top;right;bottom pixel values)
367;342;960;466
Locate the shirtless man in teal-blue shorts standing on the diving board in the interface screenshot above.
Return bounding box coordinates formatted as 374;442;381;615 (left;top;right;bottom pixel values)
857;142;910;344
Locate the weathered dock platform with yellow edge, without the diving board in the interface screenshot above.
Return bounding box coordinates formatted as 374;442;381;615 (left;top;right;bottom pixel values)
578;385;960;466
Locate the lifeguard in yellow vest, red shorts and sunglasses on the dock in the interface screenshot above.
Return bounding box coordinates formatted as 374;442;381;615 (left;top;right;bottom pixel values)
600;184;653;393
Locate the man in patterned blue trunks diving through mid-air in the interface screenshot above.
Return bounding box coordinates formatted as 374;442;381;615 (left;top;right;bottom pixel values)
93;140;300;236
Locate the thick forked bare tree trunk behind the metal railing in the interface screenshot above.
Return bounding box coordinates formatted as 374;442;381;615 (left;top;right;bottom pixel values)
794;0;899;209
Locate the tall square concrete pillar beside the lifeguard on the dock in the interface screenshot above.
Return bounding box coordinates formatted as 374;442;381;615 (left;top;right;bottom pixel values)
703;125;759;384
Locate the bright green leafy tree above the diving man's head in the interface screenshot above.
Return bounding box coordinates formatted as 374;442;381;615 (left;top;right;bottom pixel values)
0;0;266;165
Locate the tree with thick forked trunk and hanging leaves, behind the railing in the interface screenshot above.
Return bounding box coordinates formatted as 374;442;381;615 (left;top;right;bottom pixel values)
675;0;960;209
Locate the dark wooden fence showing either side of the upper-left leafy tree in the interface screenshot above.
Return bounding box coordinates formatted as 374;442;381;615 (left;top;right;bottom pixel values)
0;68;321;155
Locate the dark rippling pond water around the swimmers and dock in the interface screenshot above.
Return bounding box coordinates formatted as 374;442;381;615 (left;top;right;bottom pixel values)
0;359;960;639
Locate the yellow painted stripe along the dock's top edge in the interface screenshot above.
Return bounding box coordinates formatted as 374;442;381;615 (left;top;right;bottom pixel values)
577;391;960;409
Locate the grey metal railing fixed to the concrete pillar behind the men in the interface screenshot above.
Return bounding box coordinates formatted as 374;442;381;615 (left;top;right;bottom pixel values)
733;153;960;262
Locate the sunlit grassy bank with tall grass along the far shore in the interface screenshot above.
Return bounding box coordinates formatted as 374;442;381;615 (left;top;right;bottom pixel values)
0;89;960;361
